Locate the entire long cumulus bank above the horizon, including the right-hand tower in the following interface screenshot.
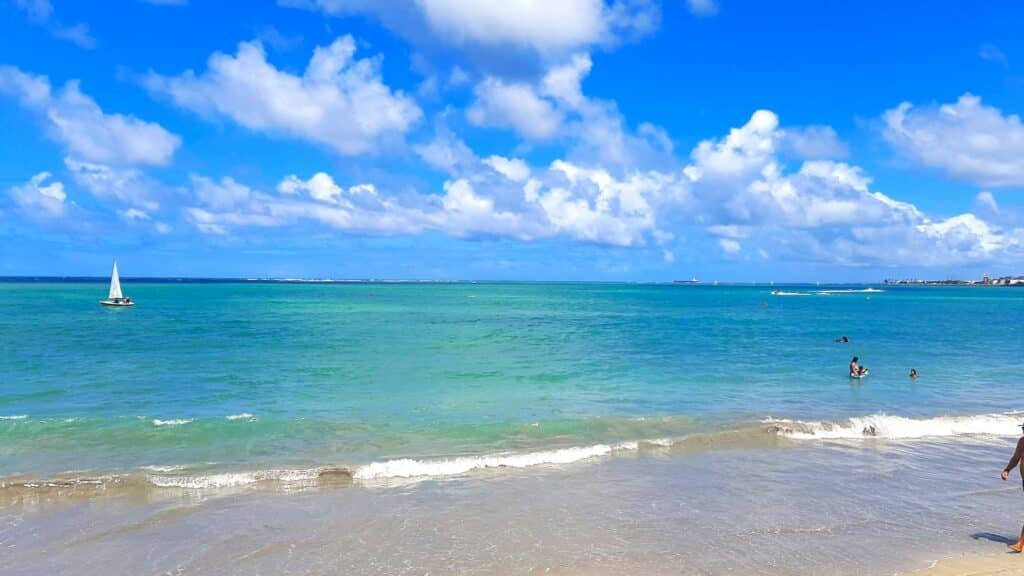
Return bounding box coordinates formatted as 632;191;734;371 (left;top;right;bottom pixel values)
176;101;1024;266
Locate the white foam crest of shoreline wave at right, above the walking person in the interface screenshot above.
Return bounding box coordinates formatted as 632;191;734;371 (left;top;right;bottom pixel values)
764;413;1022;440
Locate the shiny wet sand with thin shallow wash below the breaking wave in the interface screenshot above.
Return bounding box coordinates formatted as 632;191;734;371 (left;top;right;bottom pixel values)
0;440;1024;576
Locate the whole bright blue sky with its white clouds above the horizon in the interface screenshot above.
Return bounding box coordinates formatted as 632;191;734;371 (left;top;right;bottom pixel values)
0;0;1024;281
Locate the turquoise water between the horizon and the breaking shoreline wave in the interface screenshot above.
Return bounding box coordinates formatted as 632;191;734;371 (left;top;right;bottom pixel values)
0;282;1024;478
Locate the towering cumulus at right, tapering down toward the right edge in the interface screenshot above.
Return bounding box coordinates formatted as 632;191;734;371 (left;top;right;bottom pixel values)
683;111;1024;265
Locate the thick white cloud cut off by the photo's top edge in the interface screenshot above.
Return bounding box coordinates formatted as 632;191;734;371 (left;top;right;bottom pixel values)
280;0;659;53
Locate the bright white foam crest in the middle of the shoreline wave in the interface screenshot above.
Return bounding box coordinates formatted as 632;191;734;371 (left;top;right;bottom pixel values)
352;442;638;480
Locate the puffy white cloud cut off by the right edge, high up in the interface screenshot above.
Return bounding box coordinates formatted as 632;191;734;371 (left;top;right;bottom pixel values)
883;94;1024;188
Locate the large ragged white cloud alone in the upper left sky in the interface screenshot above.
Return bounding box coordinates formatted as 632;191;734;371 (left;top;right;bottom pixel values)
145;36;422;155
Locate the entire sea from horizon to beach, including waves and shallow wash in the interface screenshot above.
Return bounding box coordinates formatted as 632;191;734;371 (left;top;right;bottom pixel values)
0;279;1024;574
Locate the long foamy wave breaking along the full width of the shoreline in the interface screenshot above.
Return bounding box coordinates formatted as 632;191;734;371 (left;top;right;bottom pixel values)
0;413;1024;500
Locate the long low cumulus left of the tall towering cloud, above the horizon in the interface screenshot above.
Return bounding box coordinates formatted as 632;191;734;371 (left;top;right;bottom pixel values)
181;157;684;246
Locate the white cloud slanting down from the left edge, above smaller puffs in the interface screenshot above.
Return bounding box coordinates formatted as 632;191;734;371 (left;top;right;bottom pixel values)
0;67;181;165
